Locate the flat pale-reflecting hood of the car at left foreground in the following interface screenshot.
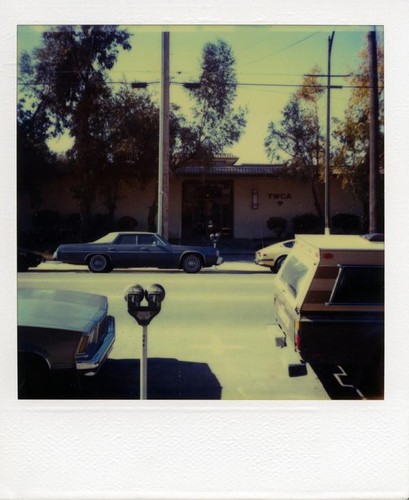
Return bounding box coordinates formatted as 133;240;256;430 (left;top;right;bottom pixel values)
17;288;108;331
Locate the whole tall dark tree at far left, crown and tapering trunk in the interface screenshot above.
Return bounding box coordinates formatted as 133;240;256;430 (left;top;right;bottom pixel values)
21;25;131;238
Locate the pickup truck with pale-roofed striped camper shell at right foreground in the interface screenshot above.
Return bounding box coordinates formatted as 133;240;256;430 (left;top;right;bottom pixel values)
273;235;384;386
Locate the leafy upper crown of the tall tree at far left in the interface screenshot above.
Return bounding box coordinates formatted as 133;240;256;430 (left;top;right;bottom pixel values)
21;25;131;136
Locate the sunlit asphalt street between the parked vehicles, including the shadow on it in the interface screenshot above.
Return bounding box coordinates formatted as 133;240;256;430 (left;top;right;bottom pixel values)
18;257;374;400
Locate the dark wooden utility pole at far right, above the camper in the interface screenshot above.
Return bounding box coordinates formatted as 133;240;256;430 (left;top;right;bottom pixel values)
368;30;379;233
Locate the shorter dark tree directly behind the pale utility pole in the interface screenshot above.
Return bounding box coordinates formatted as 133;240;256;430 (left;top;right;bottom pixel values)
100;85;188;231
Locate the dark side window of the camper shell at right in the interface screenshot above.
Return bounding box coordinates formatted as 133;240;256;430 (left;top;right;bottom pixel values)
330;266;385;305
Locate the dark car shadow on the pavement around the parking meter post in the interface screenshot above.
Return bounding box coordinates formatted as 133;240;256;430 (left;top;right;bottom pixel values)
19;358;222;399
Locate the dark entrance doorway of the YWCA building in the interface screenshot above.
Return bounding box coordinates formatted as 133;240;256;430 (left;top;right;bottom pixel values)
182;180;233;240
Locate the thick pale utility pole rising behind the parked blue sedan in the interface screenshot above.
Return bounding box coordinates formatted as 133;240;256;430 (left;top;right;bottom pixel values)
157;32;169;239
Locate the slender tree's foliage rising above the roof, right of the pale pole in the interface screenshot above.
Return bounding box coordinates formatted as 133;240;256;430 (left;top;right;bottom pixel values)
181;40;246;165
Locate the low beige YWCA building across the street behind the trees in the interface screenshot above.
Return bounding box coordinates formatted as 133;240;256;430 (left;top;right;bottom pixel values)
19;156;362;240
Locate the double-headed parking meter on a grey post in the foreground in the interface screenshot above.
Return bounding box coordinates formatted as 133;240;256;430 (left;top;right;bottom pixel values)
124;284;165;399
